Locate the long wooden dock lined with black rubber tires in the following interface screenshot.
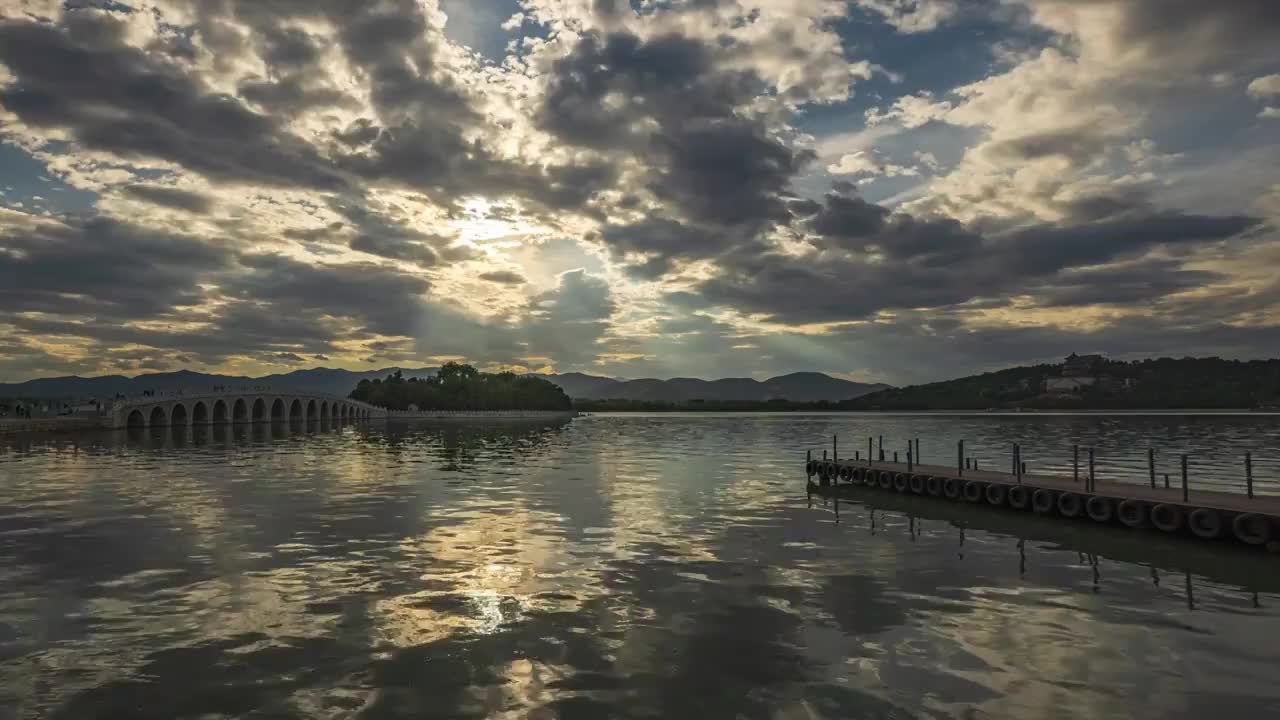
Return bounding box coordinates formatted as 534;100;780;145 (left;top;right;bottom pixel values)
805;457;1280;552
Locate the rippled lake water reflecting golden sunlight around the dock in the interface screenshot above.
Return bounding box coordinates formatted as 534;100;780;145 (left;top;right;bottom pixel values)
0;415;1280;720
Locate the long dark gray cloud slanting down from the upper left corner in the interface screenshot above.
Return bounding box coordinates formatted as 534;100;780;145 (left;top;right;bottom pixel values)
0;12;344;188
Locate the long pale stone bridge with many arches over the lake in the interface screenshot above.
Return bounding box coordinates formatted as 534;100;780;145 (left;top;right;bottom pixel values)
105;391;387;428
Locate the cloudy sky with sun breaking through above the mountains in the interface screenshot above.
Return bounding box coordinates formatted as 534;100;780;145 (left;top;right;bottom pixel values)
0;0;1280;384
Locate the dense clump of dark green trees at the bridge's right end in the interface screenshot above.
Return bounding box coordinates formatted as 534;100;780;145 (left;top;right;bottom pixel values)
351;363;572;410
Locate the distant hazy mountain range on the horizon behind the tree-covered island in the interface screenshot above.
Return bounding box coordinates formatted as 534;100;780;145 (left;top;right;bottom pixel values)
0;368;890;402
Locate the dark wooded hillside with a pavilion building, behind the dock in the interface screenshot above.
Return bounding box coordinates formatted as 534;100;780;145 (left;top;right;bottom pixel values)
838;357;1280;410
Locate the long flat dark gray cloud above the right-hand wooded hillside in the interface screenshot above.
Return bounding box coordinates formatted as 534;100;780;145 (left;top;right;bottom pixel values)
699;195;1260;323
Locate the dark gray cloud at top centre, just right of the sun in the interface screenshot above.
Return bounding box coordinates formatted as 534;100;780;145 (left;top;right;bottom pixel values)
538;32;812;242
